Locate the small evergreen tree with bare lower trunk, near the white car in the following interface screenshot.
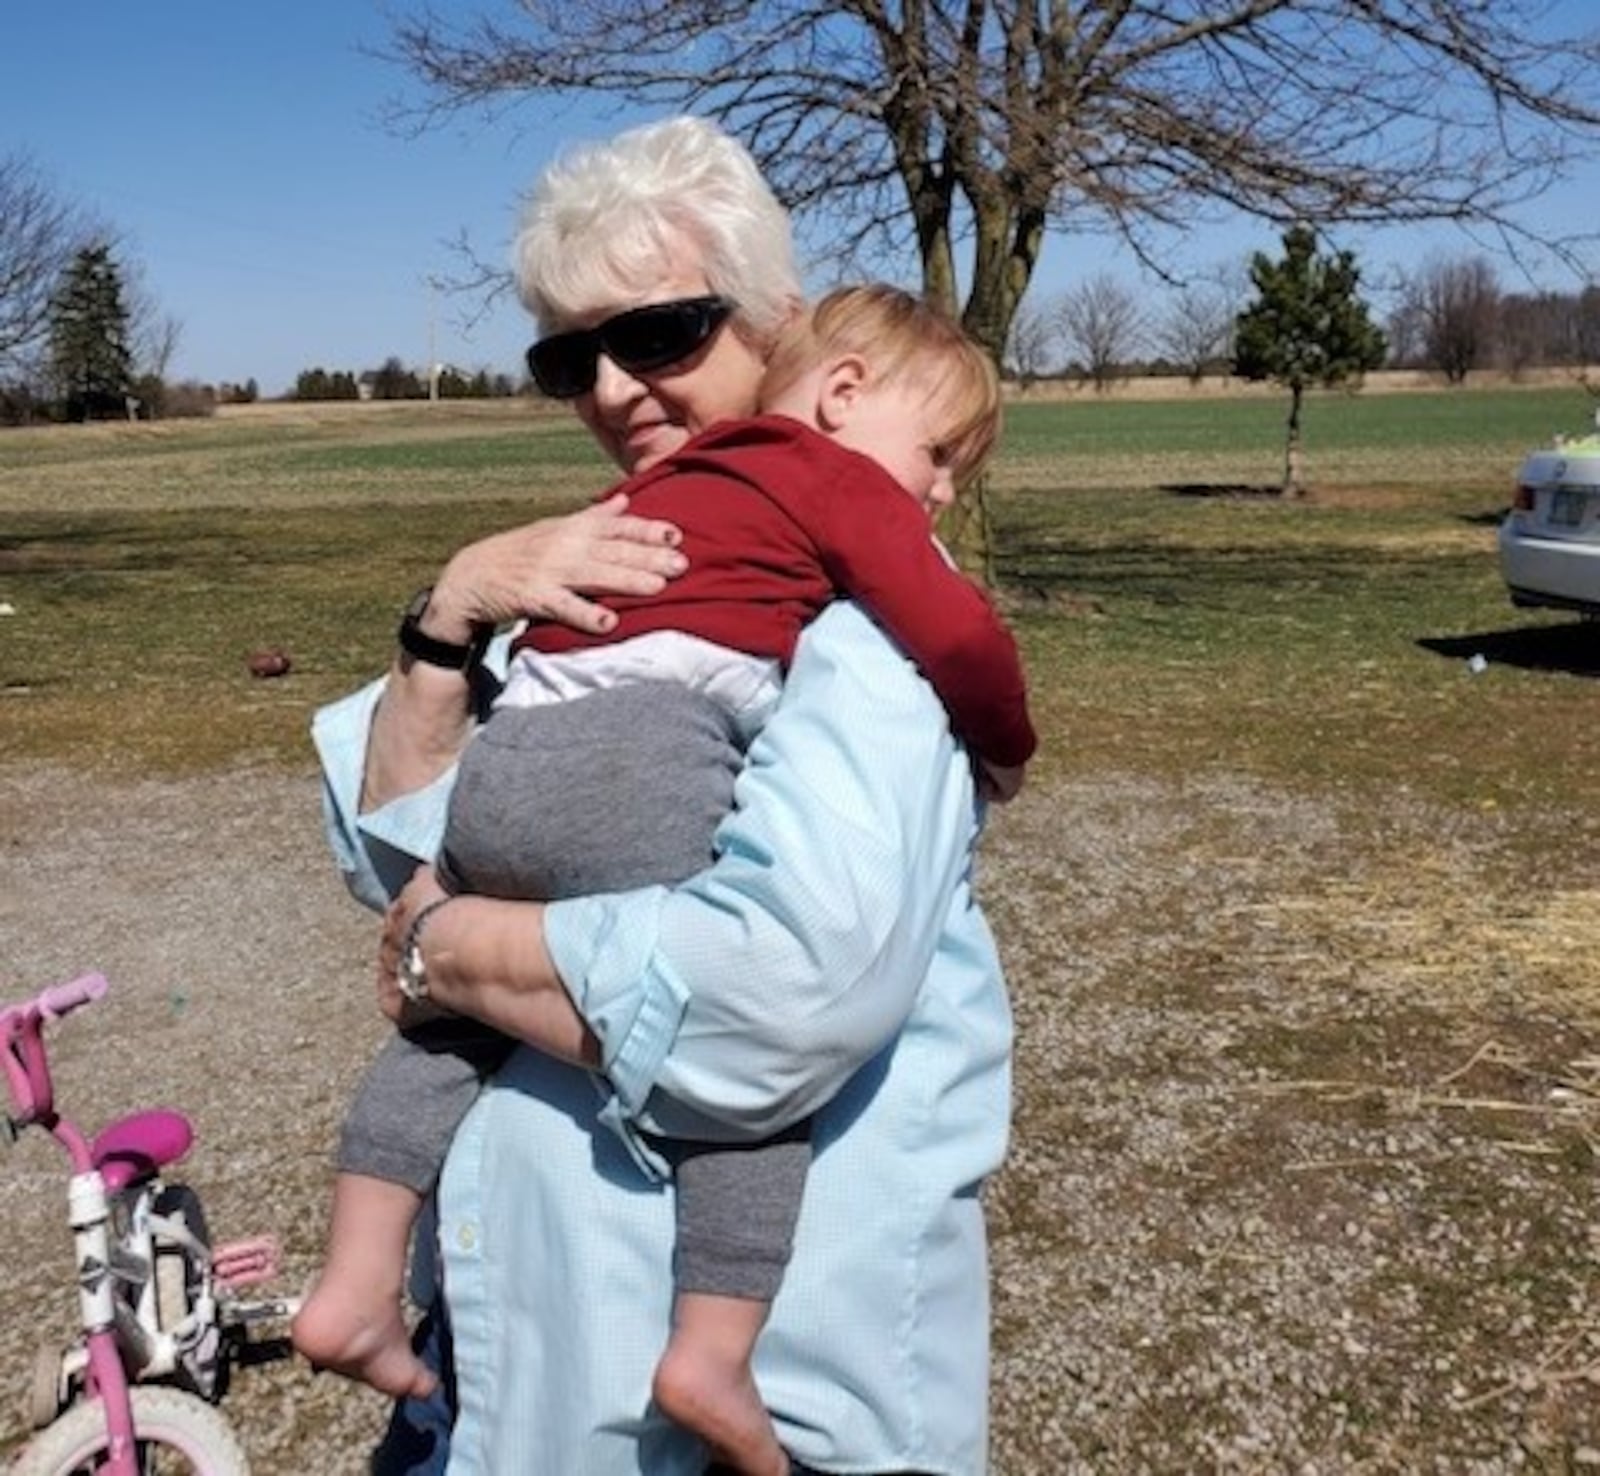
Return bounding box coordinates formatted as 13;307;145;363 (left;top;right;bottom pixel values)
1234;226;1384;496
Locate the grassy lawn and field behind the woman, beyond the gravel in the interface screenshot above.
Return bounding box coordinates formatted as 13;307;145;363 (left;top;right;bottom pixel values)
0;389;1600;812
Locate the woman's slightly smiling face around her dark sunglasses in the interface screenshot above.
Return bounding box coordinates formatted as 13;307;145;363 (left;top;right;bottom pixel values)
562;266;763;472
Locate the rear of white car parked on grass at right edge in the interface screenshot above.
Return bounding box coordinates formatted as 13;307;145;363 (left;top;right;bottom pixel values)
1499;432;1600;620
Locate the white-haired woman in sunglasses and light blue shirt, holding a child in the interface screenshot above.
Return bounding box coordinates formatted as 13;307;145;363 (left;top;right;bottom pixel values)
317;120;1010;1476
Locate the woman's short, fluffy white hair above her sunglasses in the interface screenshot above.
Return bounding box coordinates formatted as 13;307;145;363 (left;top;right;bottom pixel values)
514;117;802;344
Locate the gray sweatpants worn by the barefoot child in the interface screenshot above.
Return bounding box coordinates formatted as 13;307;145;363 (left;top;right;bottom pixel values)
339;682;811;1302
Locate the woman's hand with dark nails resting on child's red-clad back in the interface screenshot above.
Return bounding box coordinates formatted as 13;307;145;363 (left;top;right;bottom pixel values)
427;493;688;640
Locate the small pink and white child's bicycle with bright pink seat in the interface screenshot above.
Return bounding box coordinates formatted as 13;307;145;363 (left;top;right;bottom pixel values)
0;973;296;1476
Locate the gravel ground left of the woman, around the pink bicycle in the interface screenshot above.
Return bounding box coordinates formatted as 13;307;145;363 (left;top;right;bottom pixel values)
0;770;384;1476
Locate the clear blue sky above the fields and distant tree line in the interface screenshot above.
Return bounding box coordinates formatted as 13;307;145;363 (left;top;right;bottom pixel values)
0;0;1600;394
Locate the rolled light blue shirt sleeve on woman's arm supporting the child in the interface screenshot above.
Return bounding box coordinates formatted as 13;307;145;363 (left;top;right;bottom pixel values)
541;605;976;1137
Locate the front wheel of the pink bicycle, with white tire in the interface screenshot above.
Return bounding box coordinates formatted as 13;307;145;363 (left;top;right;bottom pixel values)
11;1388;250;1476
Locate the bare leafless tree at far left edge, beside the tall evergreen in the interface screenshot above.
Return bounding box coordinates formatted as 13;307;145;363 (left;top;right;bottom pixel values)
0;154;96;371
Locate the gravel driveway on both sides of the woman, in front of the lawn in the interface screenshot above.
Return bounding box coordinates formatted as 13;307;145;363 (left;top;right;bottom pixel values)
0;752;1600;1476
